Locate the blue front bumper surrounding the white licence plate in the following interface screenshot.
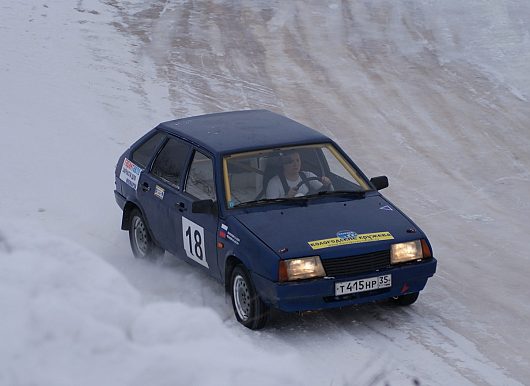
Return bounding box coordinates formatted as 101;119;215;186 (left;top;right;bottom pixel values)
252;258;437;312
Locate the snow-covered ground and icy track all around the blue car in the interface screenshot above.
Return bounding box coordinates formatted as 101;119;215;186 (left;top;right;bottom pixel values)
0;0;530;385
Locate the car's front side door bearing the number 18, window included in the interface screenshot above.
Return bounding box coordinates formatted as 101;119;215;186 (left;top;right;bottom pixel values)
175;149;219;276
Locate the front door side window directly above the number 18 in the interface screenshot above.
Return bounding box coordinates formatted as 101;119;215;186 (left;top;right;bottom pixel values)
184;151;217;201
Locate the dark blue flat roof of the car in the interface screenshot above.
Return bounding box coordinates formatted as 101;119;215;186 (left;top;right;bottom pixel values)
157;110;330;153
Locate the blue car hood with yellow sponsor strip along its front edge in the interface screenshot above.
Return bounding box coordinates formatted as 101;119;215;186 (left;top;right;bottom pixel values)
236;195;418;259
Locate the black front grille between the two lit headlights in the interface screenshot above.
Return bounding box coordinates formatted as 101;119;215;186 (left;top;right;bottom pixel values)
322;250;390;277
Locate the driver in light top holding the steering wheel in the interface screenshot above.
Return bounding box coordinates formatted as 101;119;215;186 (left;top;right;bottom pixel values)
265;151;331;198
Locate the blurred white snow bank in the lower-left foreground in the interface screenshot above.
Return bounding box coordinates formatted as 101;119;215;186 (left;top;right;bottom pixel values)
0;225;296;386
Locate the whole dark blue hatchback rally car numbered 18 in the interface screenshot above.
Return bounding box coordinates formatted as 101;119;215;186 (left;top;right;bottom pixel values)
114;110;436;329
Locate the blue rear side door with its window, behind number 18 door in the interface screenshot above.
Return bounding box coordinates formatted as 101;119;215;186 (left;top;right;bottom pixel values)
138;137;191;254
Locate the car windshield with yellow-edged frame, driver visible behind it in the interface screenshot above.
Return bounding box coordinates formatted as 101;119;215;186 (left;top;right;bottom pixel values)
223;143;370;208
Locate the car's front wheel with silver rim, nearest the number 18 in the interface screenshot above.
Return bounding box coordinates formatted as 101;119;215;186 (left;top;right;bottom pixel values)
230;264;270;330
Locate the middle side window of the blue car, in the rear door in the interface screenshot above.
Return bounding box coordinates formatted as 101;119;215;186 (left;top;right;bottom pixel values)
152;138;190;186
